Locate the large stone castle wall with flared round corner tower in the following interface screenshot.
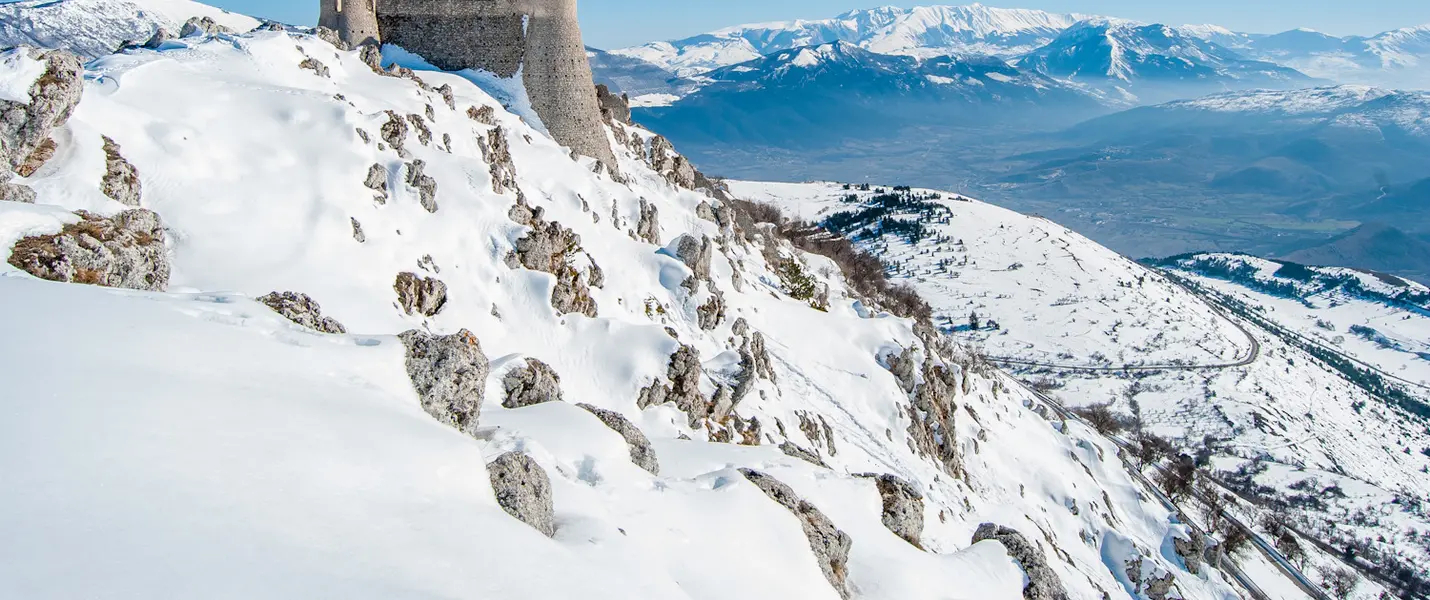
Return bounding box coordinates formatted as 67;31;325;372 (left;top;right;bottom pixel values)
377;0;616;169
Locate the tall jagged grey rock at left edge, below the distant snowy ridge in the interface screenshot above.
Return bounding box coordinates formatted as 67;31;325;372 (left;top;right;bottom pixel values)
0;47;84;173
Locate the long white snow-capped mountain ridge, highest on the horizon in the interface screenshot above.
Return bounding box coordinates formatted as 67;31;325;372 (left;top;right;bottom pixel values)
612;4;1083;76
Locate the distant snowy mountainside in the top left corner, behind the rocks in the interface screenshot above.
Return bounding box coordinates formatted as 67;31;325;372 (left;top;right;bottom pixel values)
0;0;259;59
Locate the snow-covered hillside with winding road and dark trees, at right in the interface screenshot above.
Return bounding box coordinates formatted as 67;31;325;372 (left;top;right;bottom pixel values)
732;183;1430;599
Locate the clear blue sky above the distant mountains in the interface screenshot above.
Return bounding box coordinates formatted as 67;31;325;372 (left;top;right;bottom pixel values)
207;0;1430;47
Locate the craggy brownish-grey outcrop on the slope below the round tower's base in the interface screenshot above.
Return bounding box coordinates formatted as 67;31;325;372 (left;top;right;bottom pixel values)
506;201;598;319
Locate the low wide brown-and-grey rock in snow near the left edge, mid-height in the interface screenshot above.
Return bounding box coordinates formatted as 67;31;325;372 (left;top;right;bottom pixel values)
10;209;169;291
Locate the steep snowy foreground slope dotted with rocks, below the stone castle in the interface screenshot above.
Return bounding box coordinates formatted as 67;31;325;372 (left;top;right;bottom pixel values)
0;22;1236;600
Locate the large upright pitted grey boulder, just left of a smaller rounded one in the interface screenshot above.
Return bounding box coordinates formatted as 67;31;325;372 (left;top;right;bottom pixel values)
398;329;490;434
